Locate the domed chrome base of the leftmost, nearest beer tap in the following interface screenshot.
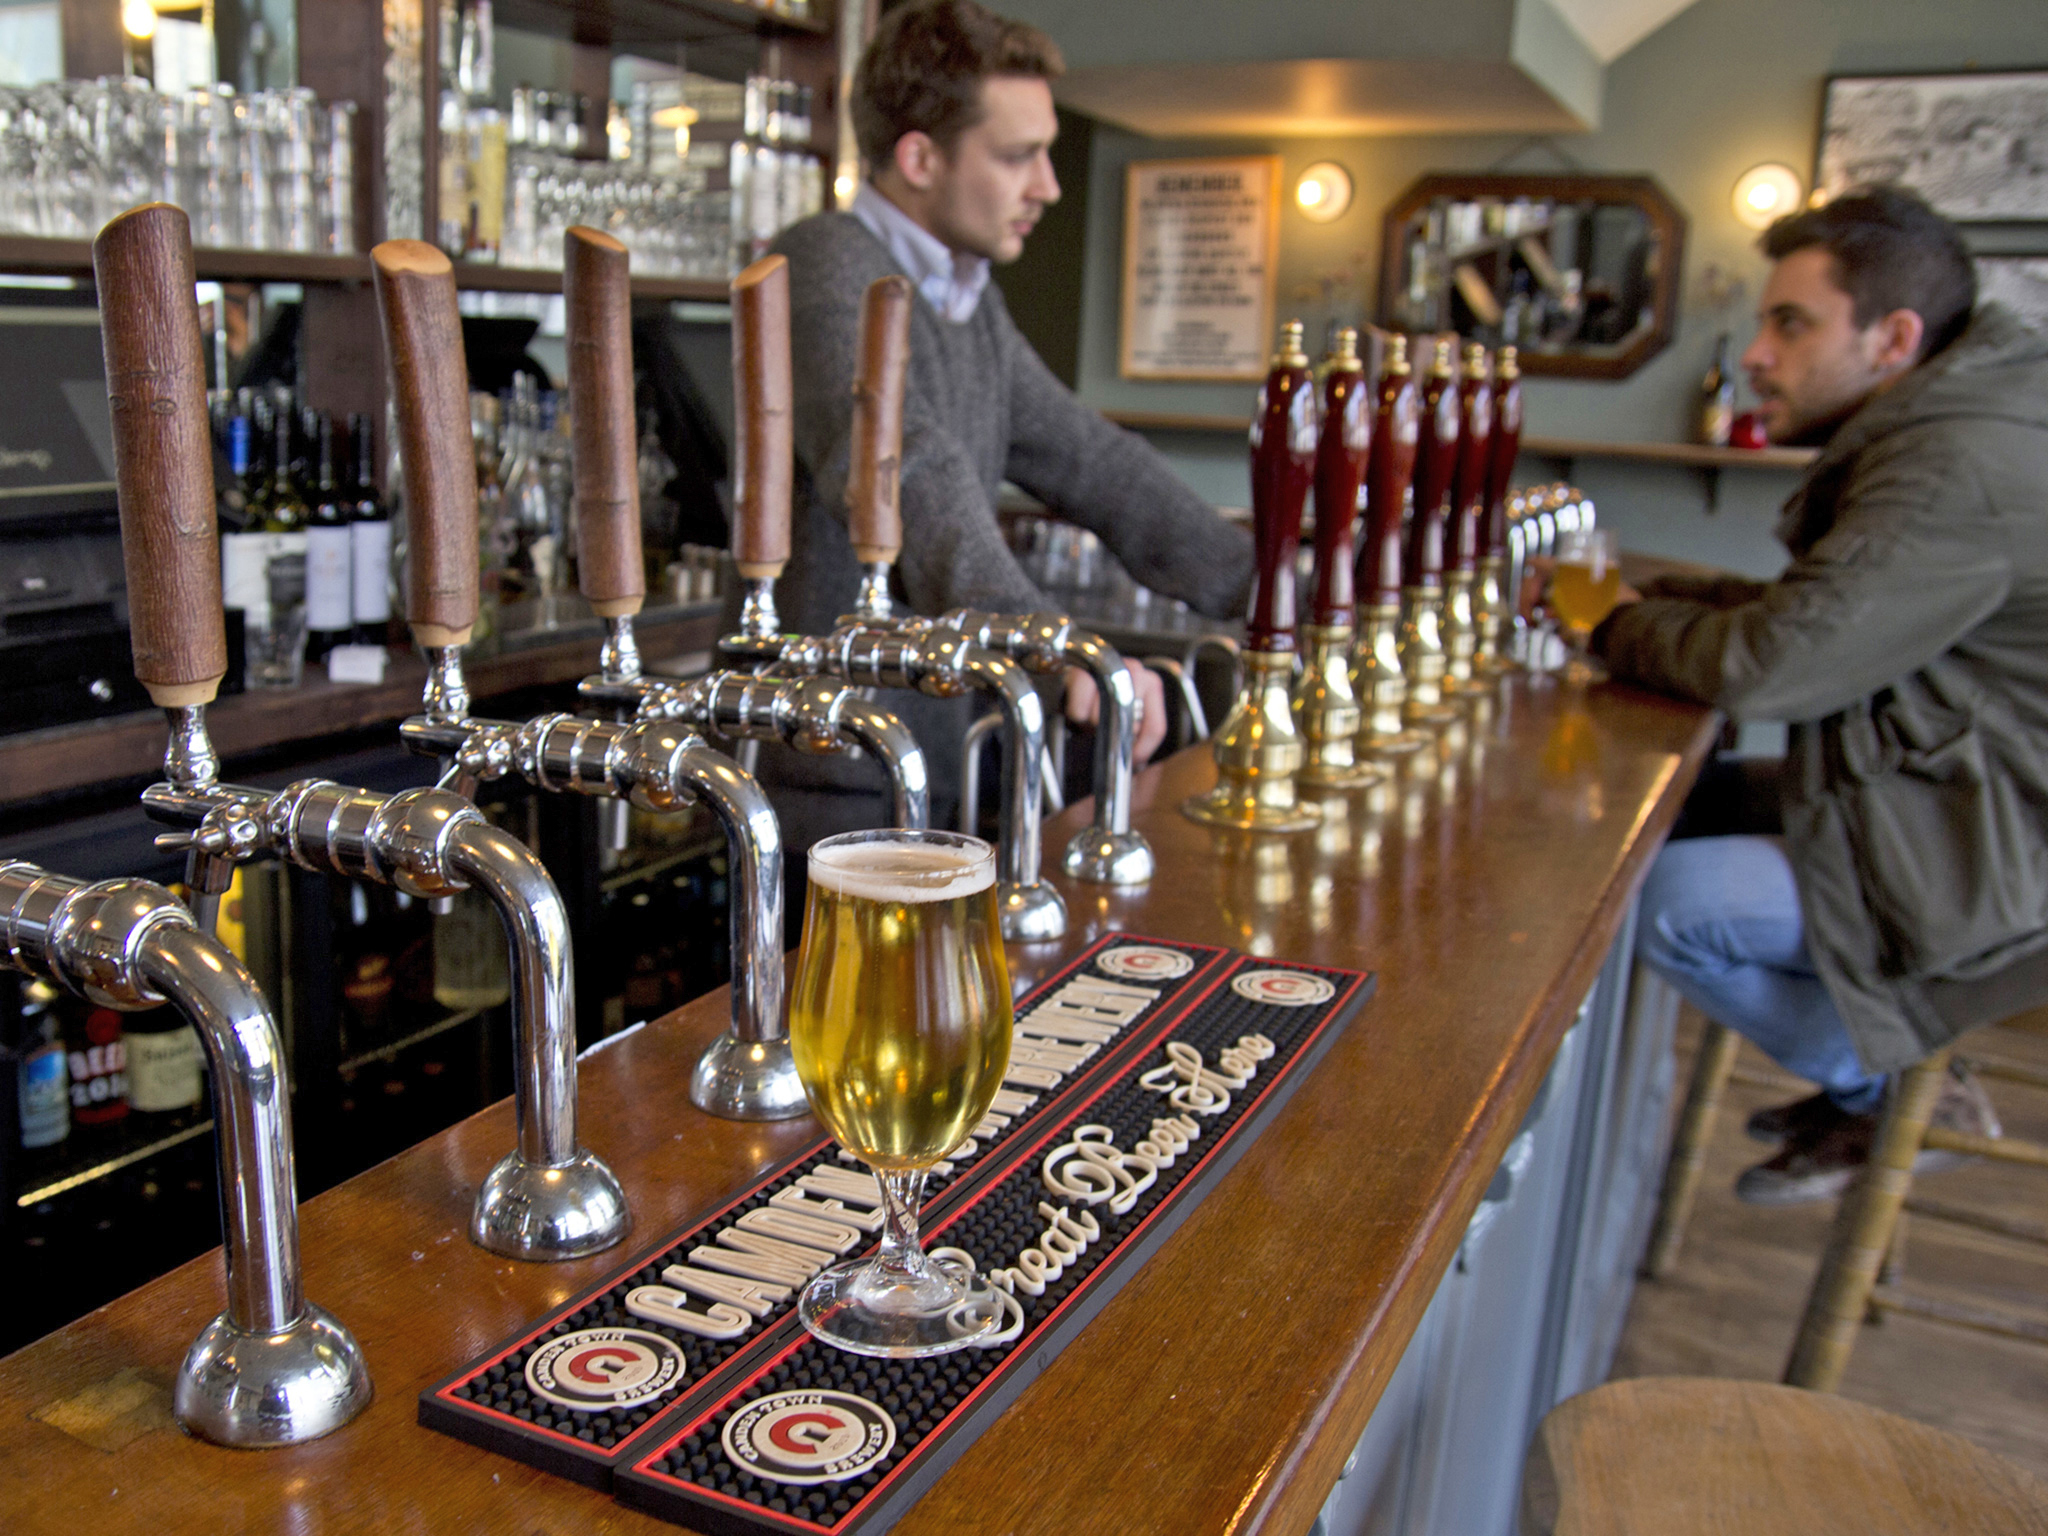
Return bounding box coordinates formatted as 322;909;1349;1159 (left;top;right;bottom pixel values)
172;1303;373;1450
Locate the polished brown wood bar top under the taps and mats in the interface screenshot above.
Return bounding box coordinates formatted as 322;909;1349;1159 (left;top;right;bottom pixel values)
0;680;1718;1536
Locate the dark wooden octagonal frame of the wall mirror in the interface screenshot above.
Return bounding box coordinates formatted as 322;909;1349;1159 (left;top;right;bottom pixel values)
1380;174;1686;379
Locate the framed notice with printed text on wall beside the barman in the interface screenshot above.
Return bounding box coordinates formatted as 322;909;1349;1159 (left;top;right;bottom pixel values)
1118;156;1280;379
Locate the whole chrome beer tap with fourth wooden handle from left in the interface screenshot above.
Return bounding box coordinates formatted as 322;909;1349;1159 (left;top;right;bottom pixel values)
719;256;1067;942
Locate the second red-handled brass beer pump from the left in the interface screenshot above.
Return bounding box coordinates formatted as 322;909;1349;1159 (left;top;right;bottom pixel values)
1294;328;1382;788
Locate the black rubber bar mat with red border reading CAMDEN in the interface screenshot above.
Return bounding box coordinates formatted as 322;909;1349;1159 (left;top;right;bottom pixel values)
420;934;1229;1489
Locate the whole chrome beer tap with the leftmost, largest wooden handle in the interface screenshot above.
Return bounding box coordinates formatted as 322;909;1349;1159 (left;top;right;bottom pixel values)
94;219;627;1260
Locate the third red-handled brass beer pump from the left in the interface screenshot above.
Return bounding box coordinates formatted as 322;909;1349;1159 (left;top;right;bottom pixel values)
1352;336;1427;758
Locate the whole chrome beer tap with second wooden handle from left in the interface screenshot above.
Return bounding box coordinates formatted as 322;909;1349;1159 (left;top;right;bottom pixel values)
371;240;807;1120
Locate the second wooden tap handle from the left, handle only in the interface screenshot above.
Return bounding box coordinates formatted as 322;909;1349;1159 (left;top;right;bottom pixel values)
371;240;477;645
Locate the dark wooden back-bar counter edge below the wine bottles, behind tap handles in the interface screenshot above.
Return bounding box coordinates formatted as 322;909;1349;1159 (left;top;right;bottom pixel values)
0;598;719;807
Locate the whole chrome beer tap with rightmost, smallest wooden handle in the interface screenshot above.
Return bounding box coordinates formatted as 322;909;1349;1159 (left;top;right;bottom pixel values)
842;274;1153;885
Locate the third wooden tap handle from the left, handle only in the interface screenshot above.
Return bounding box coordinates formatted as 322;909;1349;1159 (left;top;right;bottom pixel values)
561;225;647;618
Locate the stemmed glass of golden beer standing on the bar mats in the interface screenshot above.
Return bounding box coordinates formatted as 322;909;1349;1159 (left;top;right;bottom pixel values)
788;829;1010;1358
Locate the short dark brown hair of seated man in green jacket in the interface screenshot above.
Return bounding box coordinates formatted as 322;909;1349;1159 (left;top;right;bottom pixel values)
1759;186;1976;358
